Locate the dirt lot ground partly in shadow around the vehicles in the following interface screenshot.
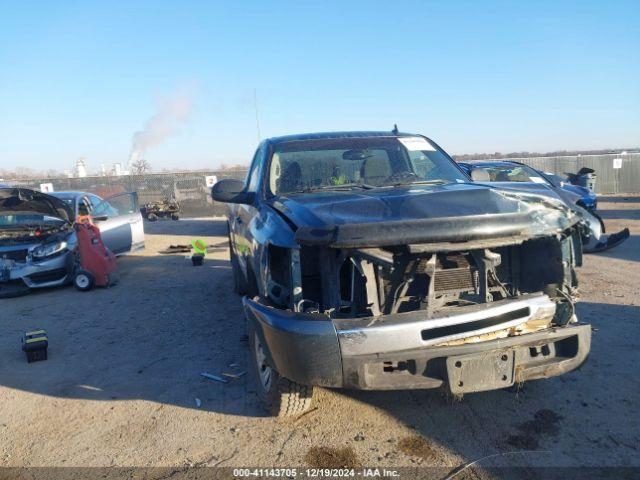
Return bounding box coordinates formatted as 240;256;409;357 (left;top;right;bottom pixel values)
0;197;640;469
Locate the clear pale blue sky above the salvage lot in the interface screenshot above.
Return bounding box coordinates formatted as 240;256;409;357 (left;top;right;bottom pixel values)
0;0;640;170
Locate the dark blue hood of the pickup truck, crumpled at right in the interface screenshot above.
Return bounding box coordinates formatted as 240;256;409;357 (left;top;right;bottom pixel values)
273;183;580;248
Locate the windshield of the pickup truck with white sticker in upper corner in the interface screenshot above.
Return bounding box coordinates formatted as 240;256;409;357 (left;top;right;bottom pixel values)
268;137;467;195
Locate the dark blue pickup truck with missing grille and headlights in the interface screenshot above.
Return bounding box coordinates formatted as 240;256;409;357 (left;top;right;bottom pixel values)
212;132;591;416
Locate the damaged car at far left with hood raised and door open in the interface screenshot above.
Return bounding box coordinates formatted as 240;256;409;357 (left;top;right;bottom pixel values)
0;187;144;296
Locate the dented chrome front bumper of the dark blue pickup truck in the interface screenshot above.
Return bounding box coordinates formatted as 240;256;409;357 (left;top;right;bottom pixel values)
244;295;591;393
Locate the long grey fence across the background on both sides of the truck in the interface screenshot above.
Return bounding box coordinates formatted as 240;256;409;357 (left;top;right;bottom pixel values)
5;153;640;217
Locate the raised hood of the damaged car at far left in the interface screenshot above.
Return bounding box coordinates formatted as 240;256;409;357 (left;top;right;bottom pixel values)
0;187;74;223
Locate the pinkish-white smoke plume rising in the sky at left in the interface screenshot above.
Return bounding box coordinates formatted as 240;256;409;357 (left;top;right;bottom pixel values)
129;91;193;166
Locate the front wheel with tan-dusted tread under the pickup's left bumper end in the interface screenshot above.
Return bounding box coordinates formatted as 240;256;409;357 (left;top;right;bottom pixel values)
249;329;313;418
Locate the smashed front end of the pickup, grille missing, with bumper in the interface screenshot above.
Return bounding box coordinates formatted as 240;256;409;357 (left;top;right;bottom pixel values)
244;188;591;394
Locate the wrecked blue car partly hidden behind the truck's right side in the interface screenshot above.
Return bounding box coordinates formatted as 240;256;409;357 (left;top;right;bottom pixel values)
459;161;631;253
